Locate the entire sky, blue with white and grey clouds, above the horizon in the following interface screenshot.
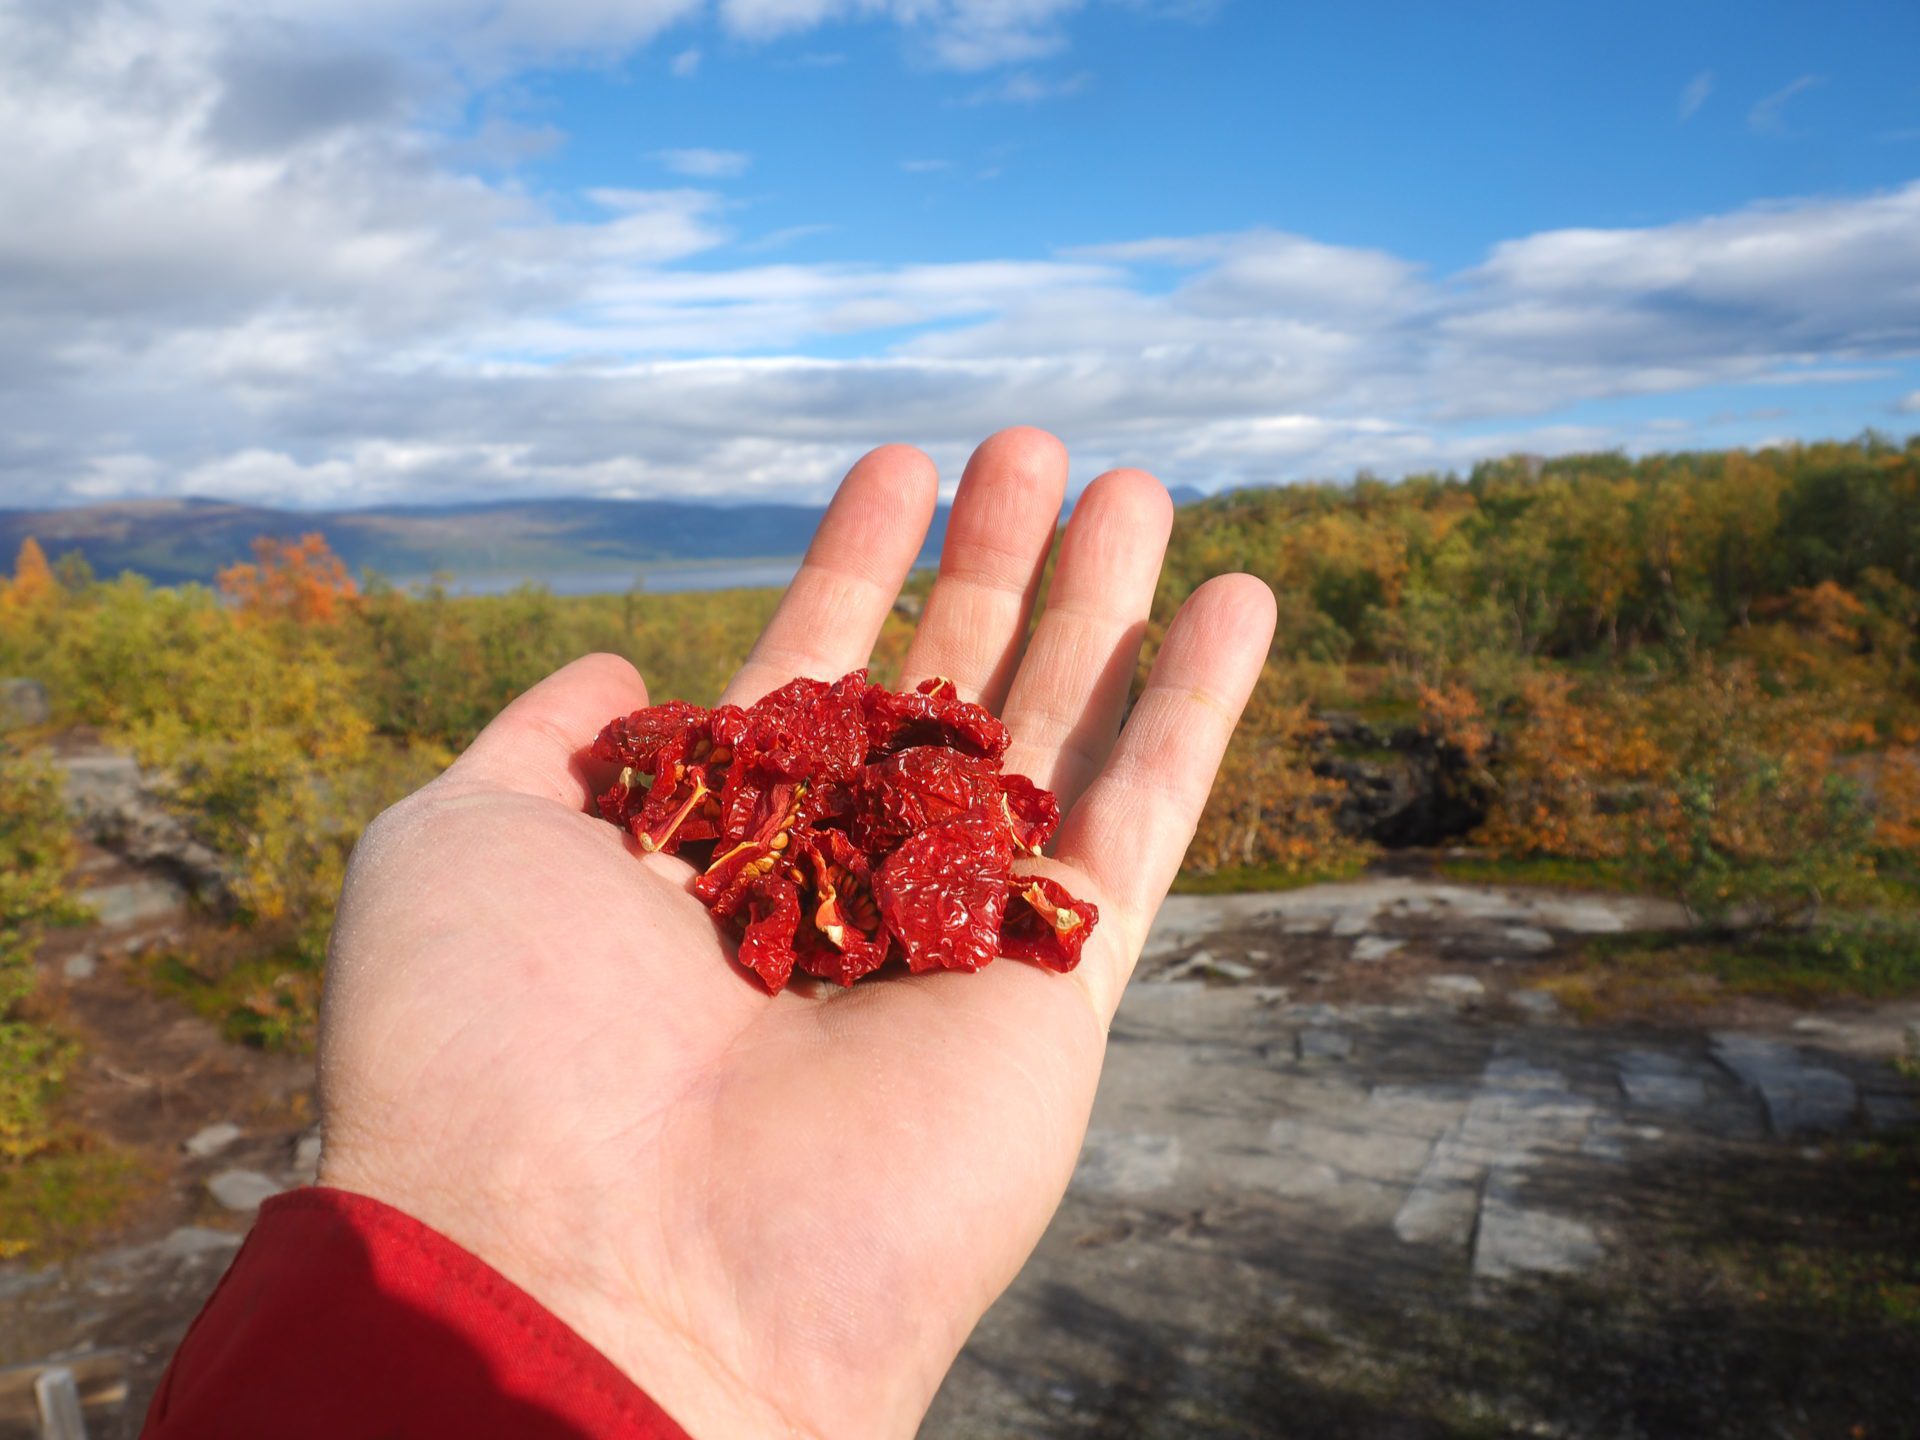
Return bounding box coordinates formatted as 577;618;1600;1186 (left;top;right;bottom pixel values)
0;0;1920;507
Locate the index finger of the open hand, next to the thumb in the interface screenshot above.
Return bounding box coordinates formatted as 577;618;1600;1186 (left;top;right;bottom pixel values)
720;445;939;705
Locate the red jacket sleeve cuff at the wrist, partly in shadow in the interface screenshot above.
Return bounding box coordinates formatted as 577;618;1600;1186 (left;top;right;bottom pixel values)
142;1187;687;1440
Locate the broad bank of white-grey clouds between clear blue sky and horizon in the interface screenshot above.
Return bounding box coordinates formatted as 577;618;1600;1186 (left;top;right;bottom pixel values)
0;0;1920;503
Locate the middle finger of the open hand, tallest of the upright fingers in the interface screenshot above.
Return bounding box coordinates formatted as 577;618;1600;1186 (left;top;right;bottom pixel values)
900;428;1068;710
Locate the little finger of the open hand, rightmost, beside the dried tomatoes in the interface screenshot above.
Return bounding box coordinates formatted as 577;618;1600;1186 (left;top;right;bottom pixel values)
1054;574;1273;1016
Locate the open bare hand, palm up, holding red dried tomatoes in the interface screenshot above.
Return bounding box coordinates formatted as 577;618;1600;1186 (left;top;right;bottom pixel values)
321;430;1273;1440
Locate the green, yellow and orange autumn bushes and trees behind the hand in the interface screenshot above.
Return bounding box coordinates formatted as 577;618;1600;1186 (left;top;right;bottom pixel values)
0;436;1920;1043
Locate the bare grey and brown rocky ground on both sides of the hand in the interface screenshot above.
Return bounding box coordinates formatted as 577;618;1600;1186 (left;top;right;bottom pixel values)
0;753;1920;1440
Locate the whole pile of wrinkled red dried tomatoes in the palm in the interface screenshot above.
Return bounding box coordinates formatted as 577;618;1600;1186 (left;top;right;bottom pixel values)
591;670;1098;991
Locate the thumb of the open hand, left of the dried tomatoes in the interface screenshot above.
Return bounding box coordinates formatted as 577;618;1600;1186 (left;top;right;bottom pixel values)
447;655;647;810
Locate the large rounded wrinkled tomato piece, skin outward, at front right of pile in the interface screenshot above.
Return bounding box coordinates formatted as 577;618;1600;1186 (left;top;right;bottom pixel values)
874;818;1012;972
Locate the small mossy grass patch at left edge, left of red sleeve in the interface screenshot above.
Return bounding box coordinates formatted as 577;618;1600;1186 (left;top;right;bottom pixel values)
0;1135;159;1260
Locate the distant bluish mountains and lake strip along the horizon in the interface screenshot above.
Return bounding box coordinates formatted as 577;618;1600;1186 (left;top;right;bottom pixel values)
0;490;1200;589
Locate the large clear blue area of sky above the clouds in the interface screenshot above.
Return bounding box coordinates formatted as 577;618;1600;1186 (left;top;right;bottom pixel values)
509;0;1920;269
